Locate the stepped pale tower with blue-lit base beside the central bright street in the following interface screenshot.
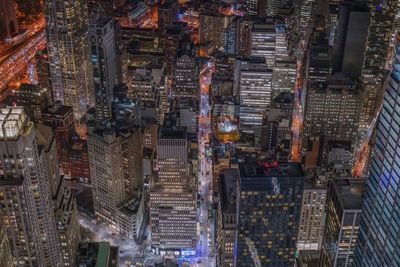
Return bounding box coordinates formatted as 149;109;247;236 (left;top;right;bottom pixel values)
150;121;197;255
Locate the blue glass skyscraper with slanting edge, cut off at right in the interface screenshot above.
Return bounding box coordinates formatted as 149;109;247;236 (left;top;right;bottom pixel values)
353;34;400;267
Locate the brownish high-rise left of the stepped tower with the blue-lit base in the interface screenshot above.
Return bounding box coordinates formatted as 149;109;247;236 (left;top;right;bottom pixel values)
88;122;143;233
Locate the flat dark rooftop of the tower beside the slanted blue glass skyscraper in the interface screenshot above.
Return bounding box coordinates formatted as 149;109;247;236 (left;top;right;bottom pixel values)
332;179;365;210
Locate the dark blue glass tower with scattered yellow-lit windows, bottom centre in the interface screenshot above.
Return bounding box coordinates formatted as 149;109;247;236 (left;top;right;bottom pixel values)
235;162;303;267
